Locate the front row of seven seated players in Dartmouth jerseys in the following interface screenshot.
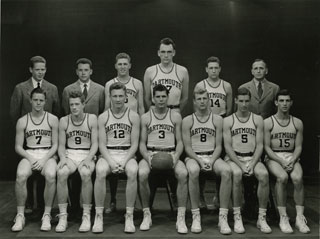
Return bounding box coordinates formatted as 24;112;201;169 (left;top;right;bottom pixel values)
12;82;310;234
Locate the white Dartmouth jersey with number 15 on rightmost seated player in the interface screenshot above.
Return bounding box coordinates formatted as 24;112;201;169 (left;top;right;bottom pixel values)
270;115;297;152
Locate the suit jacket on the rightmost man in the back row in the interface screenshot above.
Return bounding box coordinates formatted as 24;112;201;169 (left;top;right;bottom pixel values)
239;80;280;119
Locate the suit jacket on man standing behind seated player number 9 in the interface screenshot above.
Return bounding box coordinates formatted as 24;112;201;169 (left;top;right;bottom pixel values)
62;80;105;116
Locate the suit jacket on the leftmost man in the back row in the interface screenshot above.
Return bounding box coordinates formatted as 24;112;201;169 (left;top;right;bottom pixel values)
10;78;60;122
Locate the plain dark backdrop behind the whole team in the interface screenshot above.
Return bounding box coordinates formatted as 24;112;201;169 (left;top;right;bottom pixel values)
0;0;320;179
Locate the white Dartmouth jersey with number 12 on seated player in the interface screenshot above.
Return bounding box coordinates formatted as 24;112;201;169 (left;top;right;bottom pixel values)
105;108;131;147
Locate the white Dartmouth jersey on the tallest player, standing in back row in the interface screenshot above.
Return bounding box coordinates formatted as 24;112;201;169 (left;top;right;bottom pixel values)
151;63;182;106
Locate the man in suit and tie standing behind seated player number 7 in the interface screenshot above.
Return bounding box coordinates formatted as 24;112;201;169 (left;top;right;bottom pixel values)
10;56;60;213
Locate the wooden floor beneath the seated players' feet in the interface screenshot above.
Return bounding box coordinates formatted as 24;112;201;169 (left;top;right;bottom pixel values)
0;176;320;239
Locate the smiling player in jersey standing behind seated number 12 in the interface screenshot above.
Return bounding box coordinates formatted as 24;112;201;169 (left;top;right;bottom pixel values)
105;53;144;213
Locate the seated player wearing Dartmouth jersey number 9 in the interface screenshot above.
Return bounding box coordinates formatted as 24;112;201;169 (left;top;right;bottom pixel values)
56;91;98;232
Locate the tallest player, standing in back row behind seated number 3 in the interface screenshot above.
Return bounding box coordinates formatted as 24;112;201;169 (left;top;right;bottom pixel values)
144;38;189;112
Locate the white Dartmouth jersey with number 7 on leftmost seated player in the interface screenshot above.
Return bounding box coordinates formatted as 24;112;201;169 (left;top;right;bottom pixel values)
24;112;52;149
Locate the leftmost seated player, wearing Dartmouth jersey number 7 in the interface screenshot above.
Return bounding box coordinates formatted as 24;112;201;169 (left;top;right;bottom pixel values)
11;87;58;232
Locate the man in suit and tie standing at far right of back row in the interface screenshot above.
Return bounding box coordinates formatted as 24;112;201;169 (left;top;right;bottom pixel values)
239;59;279;119
